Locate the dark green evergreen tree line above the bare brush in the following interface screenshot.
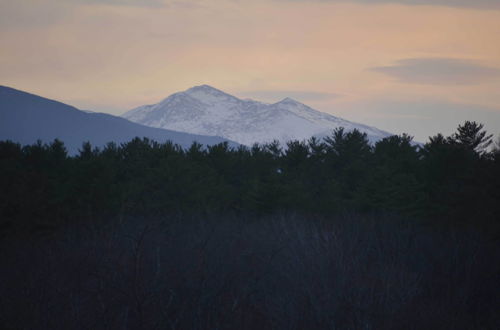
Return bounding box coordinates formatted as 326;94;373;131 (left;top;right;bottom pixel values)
0;121;500;232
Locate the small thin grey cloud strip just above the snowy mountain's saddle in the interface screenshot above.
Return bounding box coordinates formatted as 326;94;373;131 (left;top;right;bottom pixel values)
237;90;340;102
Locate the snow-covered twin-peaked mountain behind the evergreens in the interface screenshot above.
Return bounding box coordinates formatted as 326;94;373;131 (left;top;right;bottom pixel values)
122;85;392;145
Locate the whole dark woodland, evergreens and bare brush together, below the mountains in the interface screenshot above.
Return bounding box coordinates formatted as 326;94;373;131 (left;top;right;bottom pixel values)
0;122;500;329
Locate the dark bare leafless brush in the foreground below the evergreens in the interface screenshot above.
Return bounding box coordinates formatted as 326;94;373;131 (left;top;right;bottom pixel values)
0;214;500;329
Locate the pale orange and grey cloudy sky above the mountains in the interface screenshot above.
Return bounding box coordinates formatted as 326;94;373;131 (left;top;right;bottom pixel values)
0;0;500;142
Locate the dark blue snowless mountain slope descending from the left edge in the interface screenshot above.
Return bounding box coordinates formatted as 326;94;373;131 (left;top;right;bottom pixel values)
0;86;237;154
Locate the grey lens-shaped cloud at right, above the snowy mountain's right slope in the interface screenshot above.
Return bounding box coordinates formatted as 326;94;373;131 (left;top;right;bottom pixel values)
370;58;500;85
